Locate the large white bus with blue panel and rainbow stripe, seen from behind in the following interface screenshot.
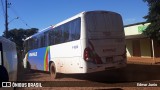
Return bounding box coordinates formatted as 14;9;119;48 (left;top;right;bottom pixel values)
24;11;126;78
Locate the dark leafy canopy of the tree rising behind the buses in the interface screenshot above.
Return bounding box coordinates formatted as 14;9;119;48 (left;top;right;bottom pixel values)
2;28;38;52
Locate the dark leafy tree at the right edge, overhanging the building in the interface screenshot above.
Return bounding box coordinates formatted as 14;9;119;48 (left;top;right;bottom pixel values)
143;0;160;43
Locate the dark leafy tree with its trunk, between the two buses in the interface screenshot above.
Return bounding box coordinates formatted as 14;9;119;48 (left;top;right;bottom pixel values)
2;28;38;74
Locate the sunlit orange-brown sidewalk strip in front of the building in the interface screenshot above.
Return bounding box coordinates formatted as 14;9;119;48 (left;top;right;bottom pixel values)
127;57;160;64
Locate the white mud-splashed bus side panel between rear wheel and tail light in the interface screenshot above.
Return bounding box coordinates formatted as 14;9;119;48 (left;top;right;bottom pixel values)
50;40;83;73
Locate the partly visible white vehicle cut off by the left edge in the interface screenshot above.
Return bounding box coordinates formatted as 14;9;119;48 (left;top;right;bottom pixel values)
0;37;17;87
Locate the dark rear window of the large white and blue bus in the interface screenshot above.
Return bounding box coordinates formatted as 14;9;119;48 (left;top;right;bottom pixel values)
86;12;123;32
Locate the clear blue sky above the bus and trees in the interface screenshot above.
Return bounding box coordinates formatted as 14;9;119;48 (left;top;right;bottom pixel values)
0;0;148;36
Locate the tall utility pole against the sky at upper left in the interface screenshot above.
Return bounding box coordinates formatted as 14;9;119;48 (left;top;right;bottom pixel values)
5;0;8;38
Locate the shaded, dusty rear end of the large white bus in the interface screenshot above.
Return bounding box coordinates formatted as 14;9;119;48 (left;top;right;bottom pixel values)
83;11;126;72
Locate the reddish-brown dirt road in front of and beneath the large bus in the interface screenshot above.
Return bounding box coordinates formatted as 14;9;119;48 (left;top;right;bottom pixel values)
16;64;160;90
